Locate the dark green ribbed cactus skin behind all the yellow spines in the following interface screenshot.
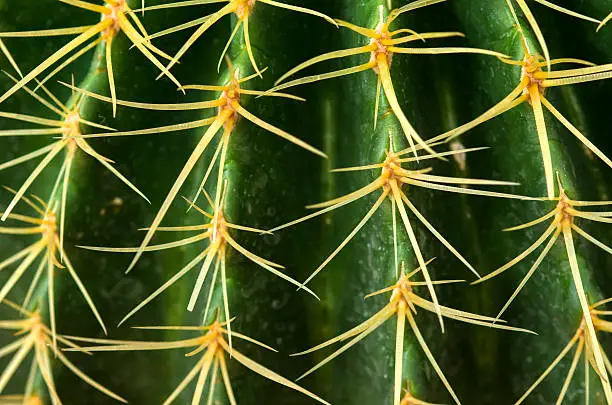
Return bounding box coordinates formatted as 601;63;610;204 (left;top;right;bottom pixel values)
0;0;612;405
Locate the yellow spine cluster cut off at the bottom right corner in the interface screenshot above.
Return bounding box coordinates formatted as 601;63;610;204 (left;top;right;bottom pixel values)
514;298;612;405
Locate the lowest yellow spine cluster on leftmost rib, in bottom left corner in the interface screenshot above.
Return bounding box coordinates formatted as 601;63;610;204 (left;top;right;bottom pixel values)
0;299;127;405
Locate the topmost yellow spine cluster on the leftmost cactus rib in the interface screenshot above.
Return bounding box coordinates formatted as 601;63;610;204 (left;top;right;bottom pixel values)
0;0;181;109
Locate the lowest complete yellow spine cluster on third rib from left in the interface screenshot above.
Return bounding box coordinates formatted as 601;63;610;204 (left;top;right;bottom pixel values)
295;263;533;405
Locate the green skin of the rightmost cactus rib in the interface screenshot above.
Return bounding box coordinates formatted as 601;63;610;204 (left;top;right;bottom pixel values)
454;1;609;404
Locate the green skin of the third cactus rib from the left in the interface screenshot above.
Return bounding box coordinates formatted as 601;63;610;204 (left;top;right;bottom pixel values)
304;0;424;403
